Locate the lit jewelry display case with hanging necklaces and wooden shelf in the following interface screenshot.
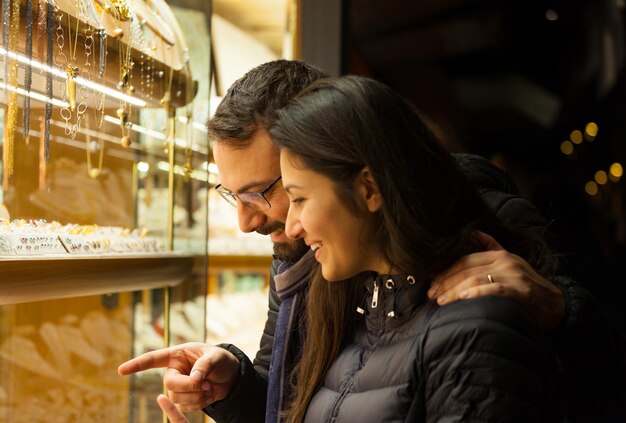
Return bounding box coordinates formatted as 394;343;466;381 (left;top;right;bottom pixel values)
0;0;210;423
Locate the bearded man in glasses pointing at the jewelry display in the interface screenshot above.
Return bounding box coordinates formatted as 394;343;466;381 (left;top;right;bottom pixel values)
119;60;623;423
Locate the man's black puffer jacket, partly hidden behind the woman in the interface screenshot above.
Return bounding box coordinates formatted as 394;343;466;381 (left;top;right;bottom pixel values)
204;154;626;423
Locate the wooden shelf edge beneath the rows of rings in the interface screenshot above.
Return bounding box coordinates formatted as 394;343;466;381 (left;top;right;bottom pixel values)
0;254;194;305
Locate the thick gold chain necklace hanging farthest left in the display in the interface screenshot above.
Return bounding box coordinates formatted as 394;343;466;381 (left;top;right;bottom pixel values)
2;0;20;189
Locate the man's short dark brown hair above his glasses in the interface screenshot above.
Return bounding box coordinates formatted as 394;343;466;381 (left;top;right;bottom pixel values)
207;59;328;147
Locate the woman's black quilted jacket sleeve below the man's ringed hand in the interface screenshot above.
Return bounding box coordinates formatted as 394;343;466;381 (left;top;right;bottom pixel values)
422;297;560;422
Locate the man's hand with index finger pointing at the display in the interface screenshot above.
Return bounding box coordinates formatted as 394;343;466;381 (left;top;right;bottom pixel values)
118;342;239;412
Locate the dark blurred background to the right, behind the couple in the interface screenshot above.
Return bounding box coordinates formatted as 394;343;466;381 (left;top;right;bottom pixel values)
342;0;626;331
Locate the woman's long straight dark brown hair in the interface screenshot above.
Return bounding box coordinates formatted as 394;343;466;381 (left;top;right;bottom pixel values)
270;76;554;422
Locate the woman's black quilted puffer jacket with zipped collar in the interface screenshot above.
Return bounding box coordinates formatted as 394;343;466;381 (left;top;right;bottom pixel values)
305;275;559;423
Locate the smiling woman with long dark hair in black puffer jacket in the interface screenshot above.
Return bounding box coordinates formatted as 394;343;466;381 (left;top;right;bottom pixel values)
270;76;557;423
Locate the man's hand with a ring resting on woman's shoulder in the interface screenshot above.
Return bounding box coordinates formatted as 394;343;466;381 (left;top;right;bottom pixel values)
428;232;565;330
